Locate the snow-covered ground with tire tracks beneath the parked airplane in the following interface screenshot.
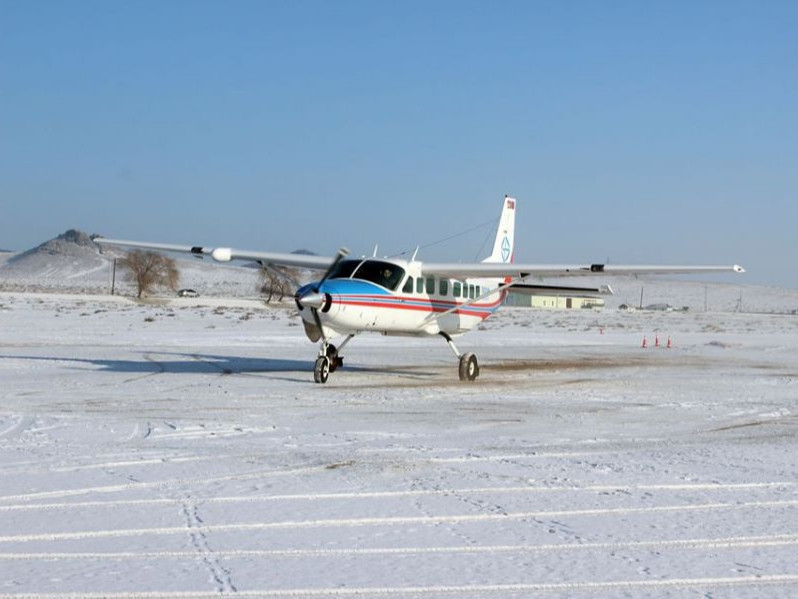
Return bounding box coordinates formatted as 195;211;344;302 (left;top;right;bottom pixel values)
0;288;798;598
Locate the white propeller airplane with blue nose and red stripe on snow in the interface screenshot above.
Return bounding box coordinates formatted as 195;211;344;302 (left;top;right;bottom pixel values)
96;196;745;384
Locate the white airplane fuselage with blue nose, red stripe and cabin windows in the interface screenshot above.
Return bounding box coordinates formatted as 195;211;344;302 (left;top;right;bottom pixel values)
296;258;506;341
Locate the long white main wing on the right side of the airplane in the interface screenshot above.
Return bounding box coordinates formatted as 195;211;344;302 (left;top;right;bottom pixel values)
421;262;745;280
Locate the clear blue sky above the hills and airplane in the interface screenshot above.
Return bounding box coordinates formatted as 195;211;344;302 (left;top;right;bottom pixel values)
0;0;798;287
